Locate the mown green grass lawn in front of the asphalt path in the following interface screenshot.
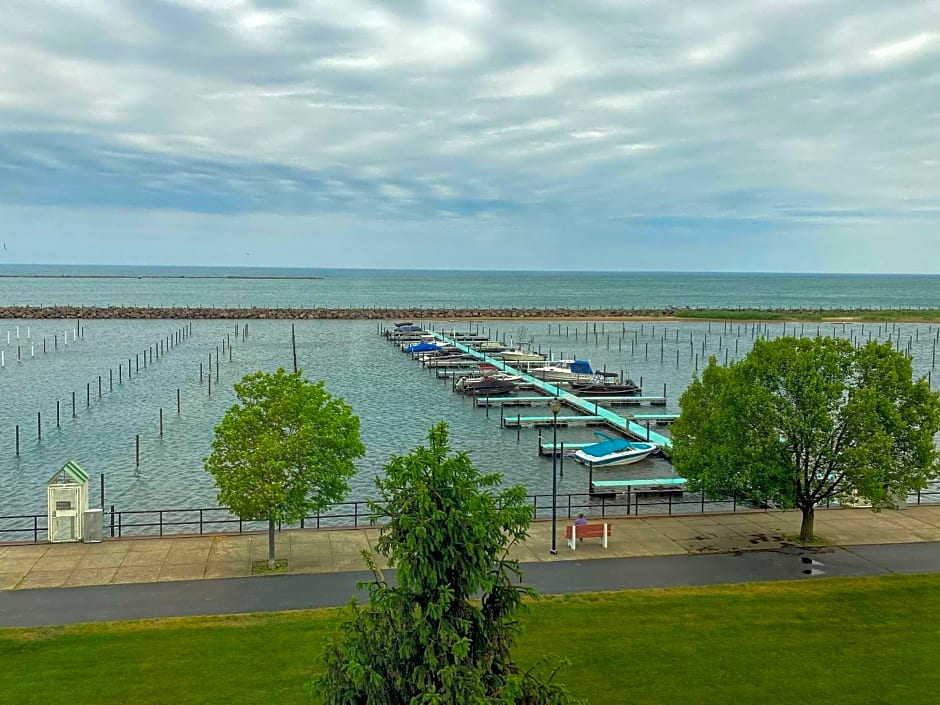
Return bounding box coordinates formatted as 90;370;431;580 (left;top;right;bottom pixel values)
0;575;940;705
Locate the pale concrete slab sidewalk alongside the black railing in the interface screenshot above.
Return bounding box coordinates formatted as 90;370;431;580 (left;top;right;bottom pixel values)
0;505;940;590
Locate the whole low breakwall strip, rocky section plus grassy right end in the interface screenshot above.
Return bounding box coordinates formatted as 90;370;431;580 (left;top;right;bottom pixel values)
0;306;940;323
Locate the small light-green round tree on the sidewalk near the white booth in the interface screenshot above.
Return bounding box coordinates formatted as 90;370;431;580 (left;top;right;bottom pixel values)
203;369;365;568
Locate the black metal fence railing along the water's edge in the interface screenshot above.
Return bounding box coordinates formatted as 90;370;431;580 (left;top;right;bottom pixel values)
0;490;940;543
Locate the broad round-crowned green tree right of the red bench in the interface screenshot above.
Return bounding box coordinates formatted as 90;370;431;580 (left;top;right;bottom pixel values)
672;338;940;541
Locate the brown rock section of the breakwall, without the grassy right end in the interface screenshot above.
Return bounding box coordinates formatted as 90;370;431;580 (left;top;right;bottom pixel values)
0;306;677;321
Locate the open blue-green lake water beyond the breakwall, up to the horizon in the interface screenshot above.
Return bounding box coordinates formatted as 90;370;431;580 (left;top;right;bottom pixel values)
0;265;940;309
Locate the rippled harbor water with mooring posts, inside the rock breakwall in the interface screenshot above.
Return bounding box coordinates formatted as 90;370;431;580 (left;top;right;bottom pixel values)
0;308;937;538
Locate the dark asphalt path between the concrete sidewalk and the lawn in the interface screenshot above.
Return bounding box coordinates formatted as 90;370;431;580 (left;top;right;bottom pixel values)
0;543;940;627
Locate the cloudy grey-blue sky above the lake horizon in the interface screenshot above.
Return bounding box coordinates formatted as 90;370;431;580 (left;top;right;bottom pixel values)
0;0;940;273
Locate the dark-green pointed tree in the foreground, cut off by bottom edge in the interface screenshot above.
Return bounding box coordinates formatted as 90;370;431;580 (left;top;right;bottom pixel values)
313;423;572;705
